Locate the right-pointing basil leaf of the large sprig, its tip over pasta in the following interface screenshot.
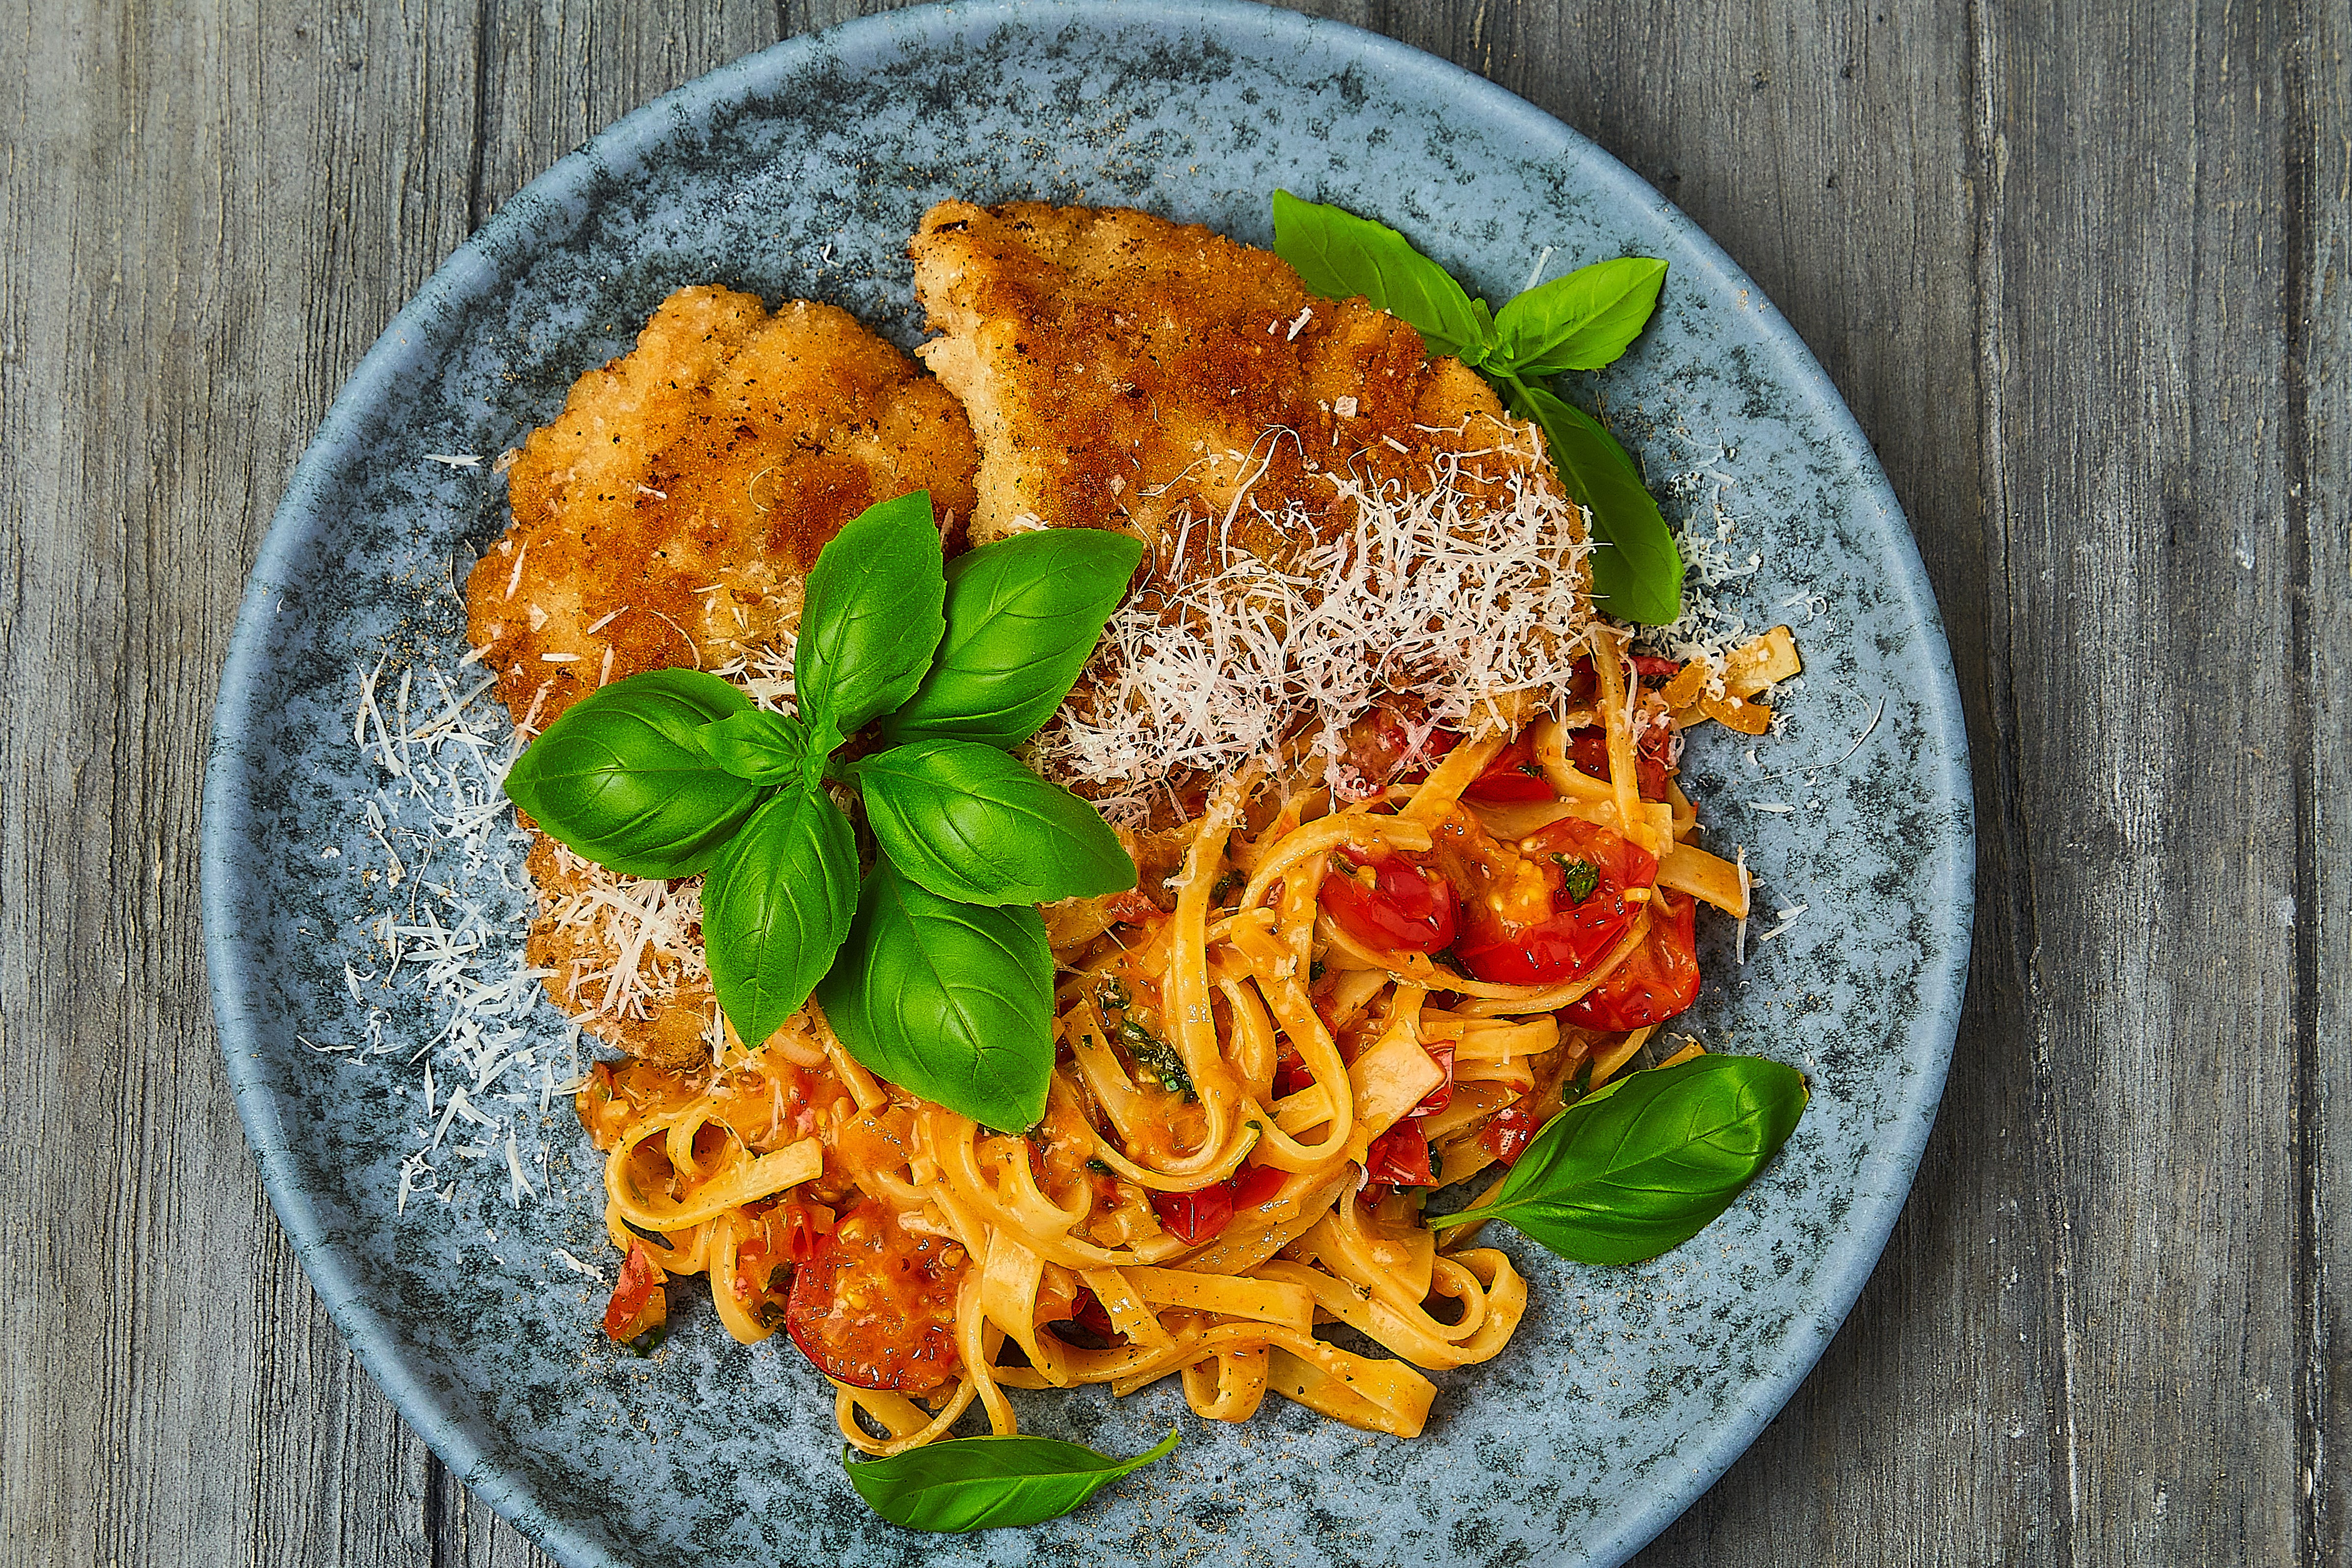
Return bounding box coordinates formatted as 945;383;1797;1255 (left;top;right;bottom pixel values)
856;741;1136;907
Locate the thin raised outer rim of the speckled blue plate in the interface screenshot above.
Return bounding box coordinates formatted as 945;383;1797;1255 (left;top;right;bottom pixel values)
200;0;1976;1568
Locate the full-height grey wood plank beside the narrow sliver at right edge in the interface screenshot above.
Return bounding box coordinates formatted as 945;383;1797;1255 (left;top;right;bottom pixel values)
1985;7;2302;1561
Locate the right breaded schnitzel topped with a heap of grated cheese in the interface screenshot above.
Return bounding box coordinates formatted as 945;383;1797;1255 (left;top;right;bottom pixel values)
913;202;1590;821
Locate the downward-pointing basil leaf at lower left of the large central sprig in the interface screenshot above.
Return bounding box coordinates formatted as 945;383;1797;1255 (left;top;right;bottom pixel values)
703;778;858;1051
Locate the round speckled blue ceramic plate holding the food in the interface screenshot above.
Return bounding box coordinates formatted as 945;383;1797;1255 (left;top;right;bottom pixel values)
205;0;1973;1566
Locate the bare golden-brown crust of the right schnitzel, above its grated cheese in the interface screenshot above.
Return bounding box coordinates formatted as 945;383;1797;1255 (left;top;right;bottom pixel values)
910;202;1552;574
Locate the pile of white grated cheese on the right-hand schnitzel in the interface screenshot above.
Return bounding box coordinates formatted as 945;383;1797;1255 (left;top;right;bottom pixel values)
1032;425;1592;825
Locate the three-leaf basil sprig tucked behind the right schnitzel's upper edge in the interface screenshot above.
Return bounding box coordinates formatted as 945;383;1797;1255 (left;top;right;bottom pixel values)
1275;190;1682;625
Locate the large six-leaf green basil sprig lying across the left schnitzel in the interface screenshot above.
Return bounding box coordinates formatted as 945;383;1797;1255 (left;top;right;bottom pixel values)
505;491;1143;1126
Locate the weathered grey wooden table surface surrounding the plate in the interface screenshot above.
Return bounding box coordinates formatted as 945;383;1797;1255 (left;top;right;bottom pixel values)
0;0;2352;1568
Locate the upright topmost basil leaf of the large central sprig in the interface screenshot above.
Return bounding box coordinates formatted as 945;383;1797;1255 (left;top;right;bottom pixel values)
793;489;948;752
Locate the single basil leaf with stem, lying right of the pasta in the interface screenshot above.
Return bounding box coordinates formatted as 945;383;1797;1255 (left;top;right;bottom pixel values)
1430;1056;1806;1262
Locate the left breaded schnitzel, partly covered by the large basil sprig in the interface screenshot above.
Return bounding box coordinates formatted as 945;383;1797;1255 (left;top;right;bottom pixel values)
466;287;976;1065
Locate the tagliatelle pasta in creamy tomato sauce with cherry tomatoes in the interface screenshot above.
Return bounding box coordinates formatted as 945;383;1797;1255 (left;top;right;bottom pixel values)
579;628;1785;1455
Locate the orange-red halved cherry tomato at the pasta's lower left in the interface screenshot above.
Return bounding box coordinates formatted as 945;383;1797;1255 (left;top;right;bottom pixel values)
783;1201;969;1394
